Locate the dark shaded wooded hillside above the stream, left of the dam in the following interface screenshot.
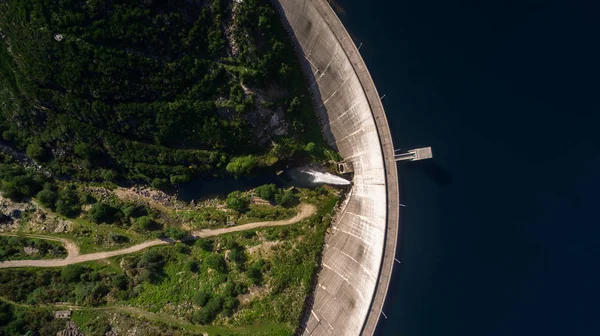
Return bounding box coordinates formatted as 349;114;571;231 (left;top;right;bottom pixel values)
0;0;325;185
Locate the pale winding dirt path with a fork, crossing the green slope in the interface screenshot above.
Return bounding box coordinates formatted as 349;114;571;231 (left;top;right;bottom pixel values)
0;203;317;268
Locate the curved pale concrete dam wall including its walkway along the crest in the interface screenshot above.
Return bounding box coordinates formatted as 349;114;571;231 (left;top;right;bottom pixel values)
273;0;399;335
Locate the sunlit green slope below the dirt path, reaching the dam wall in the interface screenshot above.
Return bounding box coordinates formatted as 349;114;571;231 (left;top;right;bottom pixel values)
0;189;336;335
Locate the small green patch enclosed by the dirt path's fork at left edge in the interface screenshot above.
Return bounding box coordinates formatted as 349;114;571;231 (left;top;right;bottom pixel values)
0;236;67;261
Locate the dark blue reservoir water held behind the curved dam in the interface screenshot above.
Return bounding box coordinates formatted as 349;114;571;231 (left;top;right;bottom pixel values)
337;0;600;336
